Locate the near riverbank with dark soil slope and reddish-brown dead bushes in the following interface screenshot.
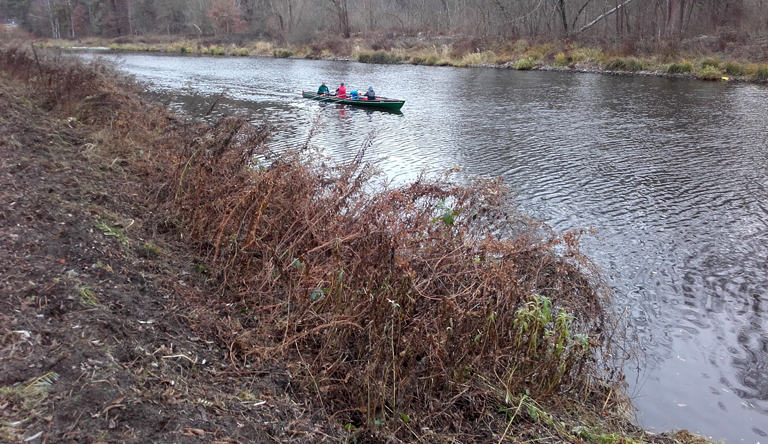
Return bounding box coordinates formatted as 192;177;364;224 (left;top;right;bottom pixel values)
0;42;712;443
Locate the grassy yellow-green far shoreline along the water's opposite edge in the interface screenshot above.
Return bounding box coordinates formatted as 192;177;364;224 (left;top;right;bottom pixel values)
36;36;768;84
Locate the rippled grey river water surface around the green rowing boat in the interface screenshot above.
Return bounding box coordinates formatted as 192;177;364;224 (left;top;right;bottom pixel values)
81;54;768;443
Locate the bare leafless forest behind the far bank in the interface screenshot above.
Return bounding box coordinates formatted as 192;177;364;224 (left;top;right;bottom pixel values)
0;0;768;52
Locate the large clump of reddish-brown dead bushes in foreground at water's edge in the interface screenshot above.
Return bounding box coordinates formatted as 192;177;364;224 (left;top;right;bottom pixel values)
165;119;606;433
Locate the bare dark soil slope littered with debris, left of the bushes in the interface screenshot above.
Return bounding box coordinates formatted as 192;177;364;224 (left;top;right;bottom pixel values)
0;78;338;443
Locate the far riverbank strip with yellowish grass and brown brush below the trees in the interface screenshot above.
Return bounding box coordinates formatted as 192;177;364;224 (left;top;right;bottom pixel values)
33;31;768;82
